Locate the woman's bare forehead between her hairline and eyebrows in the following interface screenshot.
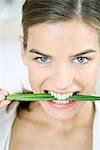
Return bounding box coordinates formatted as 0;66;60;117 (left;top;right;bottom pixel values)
28;20;98;49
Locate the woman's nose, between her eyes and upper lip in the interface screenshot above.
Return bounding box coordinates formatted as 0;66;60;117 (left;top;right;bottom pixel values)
53;66;74;90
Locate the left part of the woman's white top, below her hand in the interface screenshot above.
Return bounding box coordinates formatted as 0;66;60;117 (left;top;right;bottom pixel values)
0;103;18;150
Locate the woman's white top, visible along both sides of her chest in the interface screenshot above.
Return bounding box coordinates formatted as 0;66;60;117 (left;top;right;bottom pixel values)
0;101;100;150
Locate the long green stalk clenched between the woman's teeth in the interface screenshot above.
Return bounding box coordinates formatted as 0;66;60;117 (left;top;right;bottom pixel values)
5;94;100;101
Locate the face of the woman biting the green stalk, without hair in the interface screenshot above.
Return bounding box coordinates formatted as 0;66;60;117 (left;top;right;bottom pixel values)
22;20;100;119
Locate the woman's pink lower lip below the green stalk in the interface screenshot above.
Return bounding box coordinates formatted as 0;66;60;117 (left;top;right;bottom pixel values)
47;101;76;109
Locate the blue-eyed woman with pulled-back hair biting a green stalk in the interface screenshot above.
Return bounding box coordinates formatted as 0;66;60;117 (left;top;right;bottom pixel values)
0;0;100;150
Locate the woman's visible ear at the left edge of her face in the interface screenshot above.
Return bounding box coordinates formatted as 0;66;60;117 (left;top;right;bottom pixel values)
19;36;27;65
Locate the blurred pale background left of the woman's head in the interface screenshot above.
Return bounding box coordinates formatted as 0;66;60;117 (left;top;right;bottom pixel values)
0;0;31;92
